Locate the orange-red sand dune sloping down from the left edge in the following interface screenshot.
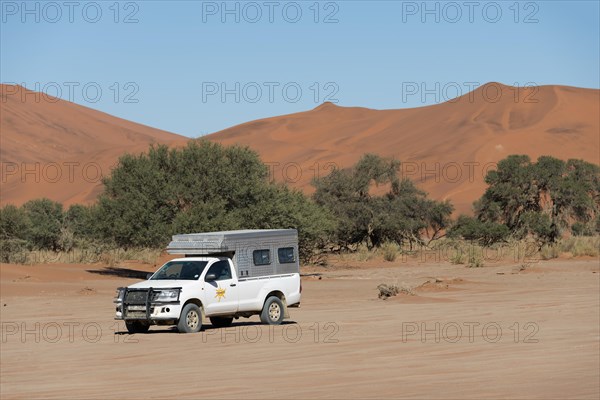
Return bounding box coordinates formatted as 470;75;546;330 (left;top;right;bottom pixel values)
0;85;187;205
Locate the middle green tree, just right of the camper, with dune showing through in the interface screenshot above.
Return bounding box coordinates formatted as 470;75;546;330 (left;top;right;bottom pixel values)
313;154;453;248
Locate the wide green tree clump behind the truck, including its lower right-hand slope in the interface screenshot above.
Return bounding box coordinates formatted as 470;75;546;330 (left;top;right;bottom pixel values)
94;140;332;256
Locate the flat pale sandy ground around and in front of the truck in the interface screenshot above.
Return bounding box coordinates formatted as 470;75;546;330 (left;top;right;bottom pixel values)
0;259;600;399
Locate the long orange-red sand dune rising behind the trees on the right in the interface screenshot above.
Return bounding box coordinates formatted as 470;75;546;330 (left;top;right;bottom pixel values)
209;83;600;212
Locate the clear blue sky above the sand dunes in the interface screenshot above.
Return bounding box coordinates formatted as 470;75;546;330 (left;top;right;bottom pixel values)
0;0;600;137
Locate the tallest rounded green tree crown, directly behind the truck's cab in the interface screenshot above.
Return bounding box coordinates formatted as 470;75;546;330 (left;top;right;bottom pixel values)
96;141;267;247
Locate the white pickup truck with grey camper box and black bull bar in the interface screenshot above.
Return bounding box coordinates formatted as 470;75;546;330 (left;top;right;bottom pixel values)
114;229;302;333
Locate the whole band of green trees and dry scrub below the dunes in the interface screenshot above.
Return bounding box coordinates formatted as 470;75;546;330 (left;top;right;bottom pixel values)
0;150;600;268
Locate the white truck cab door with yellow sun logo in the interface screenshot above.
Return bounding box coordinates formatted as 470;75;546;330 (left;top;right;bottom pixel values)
204;260;238;316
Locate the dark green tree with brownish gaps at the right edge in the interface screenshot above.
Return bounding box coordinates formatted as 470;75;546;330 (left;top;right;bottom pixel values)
475;155;600;242
